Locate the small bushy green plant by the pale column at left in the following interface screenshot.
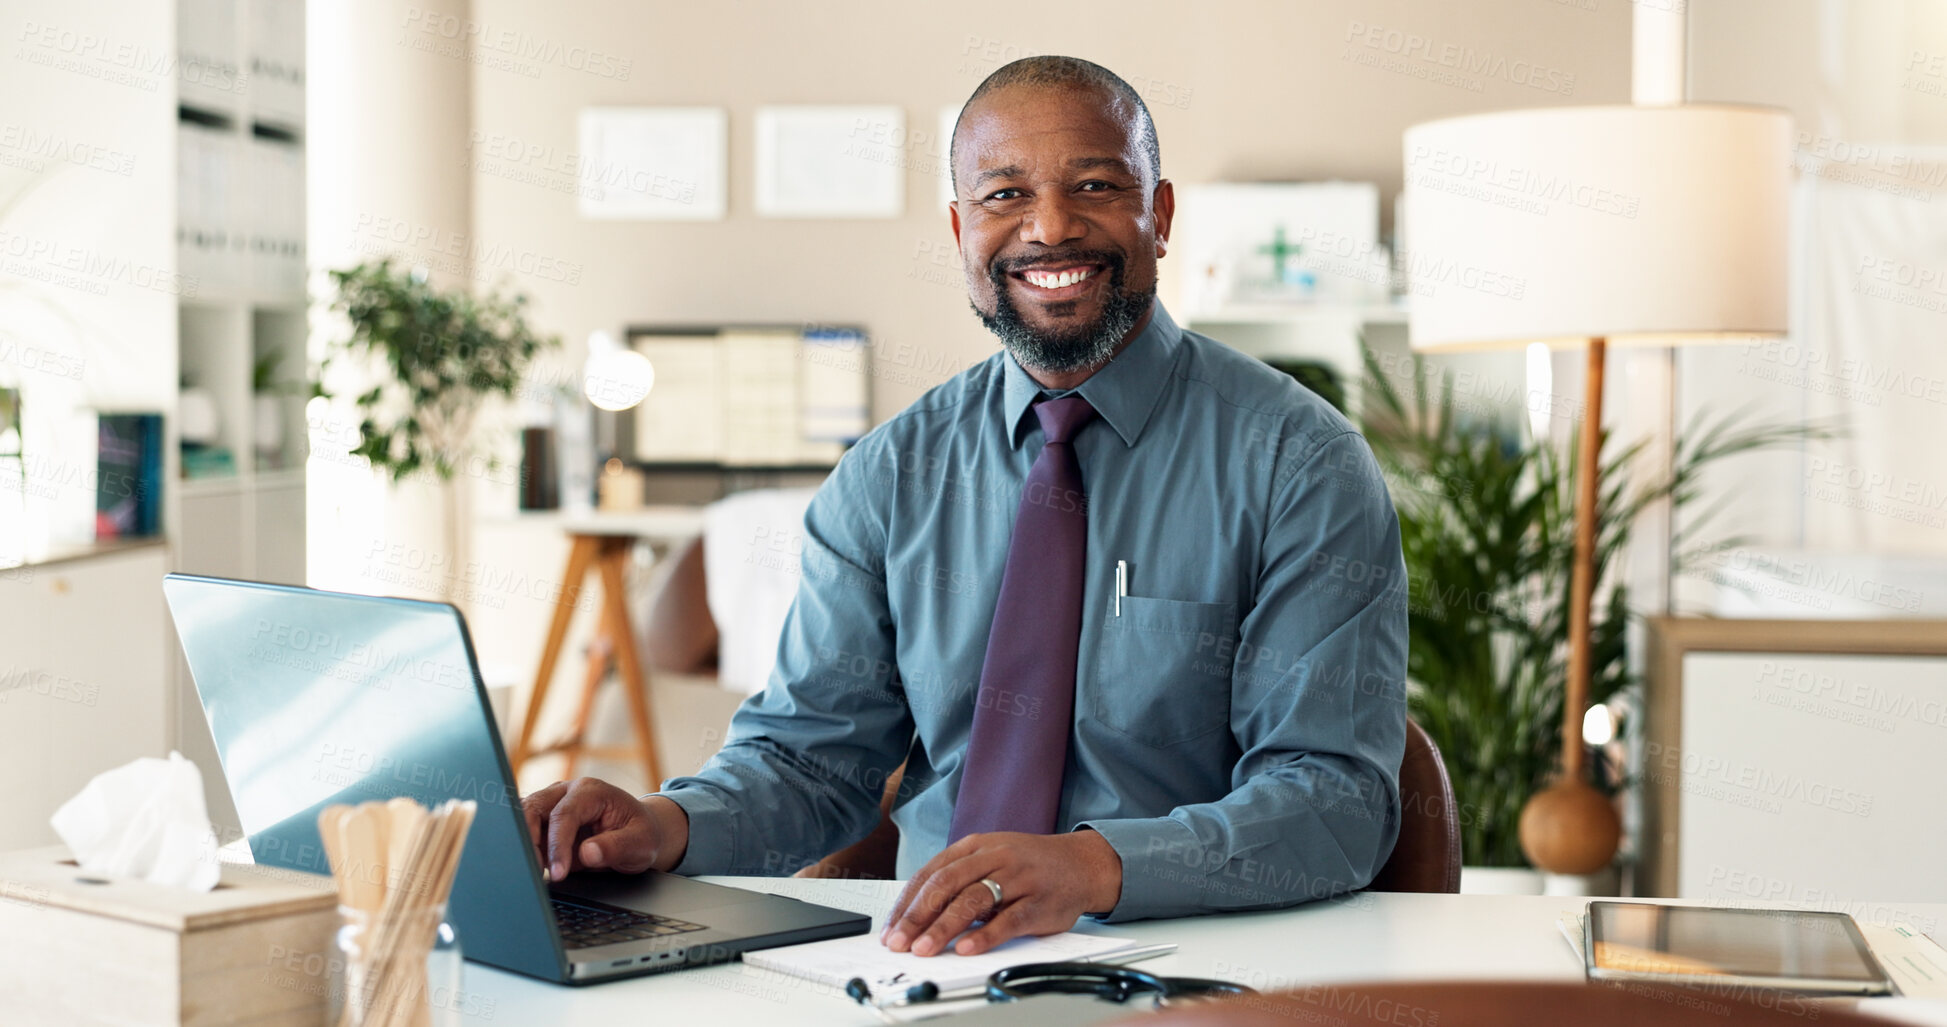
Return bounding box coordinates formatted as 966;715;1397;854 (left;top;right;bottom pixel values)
325;257;561;596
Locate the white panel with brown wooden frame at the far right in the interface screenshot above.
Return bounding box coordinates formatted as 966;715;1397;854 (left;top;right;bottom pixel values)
1637;618;1947;908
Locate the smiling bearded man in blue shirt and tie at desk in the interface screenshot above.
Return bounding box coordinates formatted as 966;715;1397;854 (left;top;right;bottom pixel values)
526;57;1406;955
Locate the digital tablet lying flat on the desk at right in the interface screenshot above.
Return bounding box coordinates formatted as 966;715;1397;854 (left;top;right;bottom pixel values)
1583;902;1894;996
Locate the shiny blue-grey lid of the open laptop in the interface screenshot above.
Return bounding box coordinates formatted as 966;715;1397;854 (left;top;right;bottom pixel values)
164;575;561;978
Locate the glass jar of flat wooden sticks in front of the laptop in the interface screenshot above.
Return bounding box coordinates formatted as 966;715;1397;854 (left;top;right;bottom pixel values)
317;799;475;1027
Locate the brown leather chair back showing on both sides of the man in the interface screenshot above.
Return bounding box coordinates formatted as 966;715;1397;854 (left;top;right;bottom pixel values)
798;721;1460;893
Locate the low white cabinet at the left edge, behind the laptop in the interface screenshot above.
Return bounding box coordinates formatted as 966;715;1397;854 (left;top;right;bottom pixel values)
0;544;175;850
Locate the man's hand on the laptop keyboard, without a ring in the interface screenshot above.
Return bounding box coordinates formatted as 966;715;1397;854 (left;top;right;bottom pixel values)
520;778;689;881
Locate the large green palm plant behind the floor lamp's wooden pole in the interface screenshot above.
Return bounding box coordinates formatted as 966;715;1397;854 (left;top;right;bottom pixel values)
1361;351;1830;891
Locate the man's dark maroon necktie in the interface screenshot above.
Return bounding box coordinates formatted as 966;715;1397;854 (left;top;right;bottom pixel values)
948;396;1096;842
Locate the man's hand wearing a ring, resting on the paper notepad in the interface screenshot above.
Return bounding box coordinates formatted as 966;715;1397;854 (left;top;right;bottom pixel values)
882;830;1121;955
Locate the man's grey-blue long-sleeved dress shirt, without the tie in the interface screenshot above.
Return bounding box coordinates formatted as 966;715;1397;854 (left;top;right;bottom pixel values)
662;302;1406;920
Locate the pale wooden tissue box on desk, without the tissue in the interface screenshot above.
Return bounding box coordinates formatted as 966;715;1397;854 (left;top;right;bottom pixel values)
0;846;339;1027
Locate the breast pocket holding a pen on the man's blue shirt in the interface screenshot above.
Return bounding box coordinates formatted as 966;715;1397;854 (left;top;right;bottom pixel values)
1088;596;1236;748
